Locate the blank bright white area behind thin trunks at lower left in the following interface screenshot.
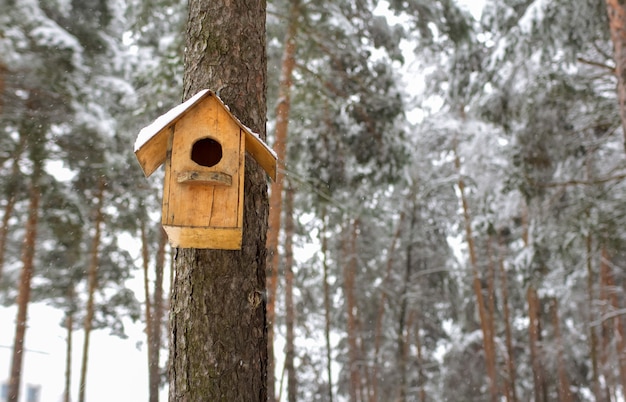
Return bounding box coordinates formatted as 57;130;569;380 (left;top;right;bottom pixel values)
0;303;167;402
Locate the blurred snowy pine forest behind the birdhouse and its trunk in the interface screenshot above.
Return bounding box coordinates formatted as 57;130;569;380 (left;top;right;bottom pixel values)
0;0;626;402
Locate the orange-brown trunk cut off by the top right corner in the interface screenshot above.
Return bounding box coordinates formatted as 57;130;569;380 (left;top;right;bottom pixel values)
606;0;626;148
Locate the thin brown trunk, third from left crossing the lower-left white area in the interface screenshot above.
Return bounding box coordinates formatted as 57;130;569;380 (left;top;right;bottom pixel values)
78;177;106;402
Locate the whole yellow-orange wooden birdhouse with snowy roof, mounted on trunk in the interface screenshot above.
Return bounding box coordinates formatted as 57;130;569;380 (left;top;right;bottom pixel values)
135;90;276;250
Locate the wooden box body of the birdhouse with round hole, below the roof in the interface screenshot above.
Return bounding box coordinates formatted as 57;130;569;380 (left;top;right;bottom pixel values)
162;98;245;249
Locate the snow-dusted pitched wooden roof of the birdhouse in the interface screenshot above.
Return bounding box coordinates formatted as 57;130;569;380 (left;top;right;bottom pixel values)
135;89;276;180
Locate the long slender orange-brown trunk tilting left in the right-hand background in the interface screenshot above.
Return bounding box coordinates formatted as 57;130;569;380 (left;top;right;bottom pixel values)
454;140;498;402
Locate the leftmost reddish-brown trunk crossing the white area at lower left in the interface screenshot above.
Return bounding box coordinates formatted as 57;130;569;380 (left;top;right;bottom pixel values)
7;155;43;402
